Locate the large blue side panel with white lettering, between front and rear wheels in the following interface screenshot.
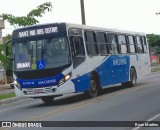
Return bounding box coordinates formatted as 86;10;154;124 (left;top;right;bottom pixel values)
96;55;130;87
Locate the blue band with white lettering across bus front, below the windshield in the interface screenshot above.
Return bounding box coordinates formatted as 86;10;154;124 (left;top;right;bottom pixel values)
17;74;64;88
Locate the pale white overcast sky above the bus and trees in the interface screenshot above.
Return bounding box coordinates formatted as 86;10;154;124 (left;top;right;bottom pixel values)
0;0;160;36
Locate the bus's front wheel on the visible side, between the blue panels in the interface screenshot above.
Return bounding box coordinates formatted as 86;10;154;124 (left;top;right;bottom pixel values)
85;79;98;98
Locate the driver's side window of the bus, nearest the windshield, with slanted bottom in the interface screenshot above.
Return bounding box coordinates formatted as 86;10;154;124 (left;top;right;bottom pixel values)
70;36;85;68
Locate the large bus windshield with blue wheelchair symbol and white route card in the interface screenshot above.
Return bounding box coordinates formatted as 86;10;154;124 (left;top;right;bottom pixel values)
13;37;70;71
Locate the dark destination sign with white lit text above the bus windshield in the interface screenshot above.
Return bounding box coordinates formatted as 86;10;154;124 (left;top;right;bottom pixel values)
12;23;67;41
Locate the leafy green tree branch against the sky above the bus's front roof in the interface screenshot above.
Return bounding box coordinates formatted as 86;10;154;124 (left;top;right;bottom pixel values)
0;2;52;28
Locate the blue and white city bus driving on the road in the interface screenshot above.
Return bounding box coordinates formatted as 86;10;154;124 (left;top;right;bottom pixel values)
7;23;151;104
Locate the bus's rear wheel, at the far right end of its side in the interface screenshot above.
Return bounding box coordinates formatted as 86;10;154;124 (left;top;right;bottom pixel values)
122;68;137;87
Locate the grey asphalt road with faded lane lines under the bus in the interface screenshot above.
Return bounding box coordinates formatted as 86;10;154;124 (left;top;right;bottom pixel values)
0;73;160;130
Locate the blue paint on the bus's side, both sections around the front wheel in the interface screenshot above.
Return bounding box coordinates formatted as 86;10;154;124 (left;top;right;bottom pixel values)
72;55;130;92
